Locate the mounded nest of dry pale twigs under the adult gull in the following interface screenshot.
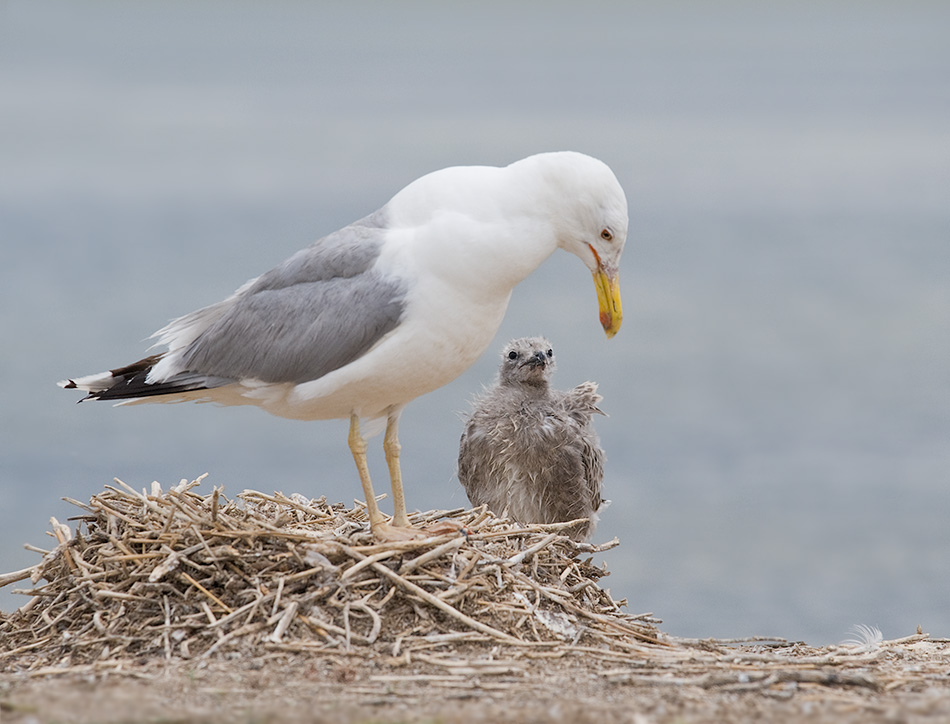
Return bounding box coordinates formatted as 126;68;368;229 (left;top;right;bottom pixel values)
0;478;660;670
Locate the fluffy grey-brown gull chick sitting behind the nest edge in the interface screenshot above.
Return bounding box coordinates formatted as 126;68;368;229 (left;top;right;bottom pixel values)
458;337;604;540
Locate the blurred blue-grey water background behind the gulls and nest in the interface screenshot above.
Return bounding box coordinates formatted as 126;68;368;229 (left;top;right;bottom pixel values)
0;0;950;644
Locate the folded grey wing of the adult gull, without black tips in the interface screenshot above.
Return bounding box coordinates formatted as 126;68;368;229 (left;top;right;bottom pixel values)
181;210;406;383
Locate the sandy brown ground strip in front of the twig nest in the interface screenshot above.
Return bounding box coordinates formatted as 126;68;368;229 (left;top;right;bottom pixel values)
0;636;950;724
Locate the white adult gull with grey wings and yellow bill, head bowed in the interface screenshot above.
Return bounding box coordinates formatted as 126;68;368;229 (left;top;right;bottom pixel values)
59;151;627;539
